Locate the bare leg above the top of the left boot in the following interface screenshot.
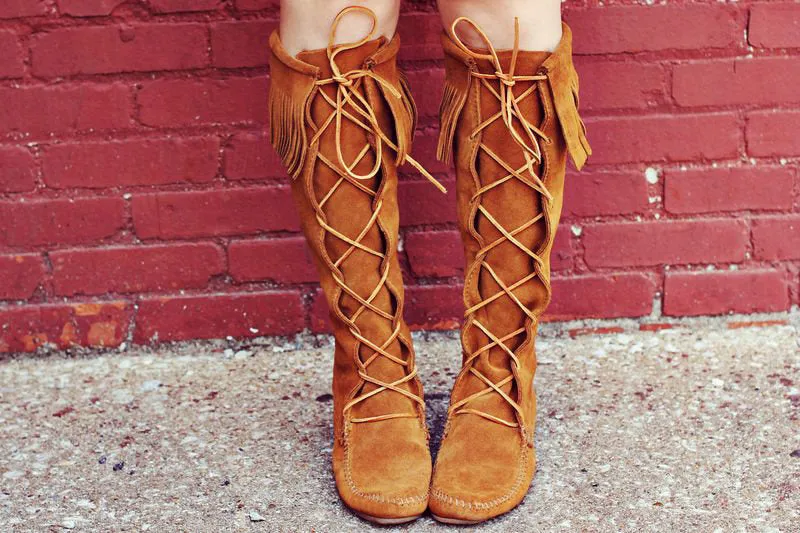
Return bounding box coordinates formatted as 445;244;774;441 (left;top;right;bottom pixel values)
280;0;400;56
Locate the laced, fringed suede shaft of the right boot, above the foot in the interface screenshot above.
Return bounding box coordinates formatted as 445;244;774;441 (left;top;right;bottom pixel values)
438;21;590;428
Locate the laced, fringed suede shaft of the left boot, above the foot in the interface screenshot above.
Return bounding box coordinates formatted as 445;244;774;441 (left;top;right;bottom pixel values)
270;15;432;439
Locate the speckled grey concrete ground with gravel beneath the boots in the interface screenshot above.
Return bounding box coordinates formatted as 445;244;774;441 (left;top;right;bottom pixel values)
0;321;800;532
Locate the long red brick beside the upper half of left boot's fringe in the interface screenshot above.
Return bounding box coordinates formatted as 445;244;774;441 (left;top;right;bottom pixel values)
137;77;269;126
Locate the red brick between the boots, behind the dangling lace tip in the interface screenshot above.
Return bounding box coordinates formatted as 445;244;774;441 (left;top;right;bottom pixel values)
397;180;456;226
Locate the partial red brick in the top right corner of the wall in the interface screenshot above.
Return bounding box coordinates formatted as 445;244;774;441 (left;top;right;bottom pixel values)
747;2;800;48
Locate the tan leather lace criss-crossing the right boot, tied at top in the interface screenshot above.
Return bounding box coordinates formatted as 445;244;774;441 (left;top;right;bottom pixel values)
450;17;553;427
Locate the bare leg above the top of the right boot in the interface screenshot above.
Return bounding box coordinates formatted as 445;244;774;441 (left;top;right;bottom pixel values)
438;0;561;52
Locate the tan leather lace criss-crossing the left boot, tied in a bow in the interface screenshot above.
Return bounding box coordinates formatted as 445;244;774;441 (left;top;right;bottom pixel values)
310;6;446;423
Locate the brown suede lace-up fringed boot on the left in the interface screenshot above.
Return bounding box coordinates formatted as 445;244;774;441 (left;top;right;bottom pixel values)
269;8;441;524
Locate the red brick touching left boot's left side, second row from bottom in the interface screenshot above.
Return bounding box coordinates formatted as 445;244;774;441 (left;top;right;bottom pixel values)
228;237;319;283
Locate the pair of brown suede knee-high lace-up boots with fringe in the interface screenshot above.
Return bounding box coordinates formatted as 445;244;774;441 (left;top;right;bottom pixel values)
269;8;590;523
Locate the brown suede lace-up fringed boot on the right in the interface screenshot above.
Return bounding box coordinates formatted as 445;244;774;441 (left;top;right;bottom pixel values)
429;19;591;524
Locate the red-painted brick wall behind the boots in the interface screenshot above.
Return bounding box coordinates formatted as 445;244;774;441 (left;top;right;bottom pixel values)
0;0;800;351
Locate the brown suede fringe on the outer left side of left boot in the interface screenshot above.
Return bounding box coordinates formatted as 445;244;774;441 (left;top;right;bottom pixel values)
269;84;308;179
